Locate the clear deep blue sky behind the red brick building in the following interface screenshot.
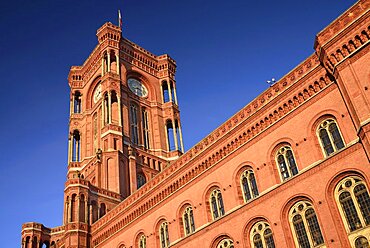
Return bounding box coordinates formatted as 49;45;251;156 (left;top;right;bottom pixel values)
0;0;355;247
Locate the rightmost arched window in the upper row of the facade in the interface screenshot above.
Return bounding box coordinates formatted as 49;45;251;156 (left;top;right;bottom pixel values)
317;119;344;156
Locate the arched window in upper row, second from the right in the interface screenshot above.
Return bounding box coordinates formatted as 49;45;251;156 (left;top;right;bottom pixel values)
276;146;298;181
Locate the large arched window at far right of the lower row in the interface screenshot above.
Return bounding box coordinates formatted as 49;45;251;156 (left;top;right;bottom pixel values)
335;176;370;242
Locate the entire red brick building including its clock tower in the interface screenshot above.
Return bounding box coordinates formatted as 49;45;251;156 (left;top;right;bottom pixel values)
22;0;370;248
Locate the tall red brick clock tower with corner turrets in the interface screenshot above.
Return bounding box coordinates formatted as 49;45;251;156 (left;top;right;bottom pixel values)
60;20;184;247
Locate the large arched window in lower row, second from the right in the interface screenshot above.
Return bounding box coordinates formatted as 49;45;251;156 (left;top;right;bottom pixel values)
289;201;324;248
